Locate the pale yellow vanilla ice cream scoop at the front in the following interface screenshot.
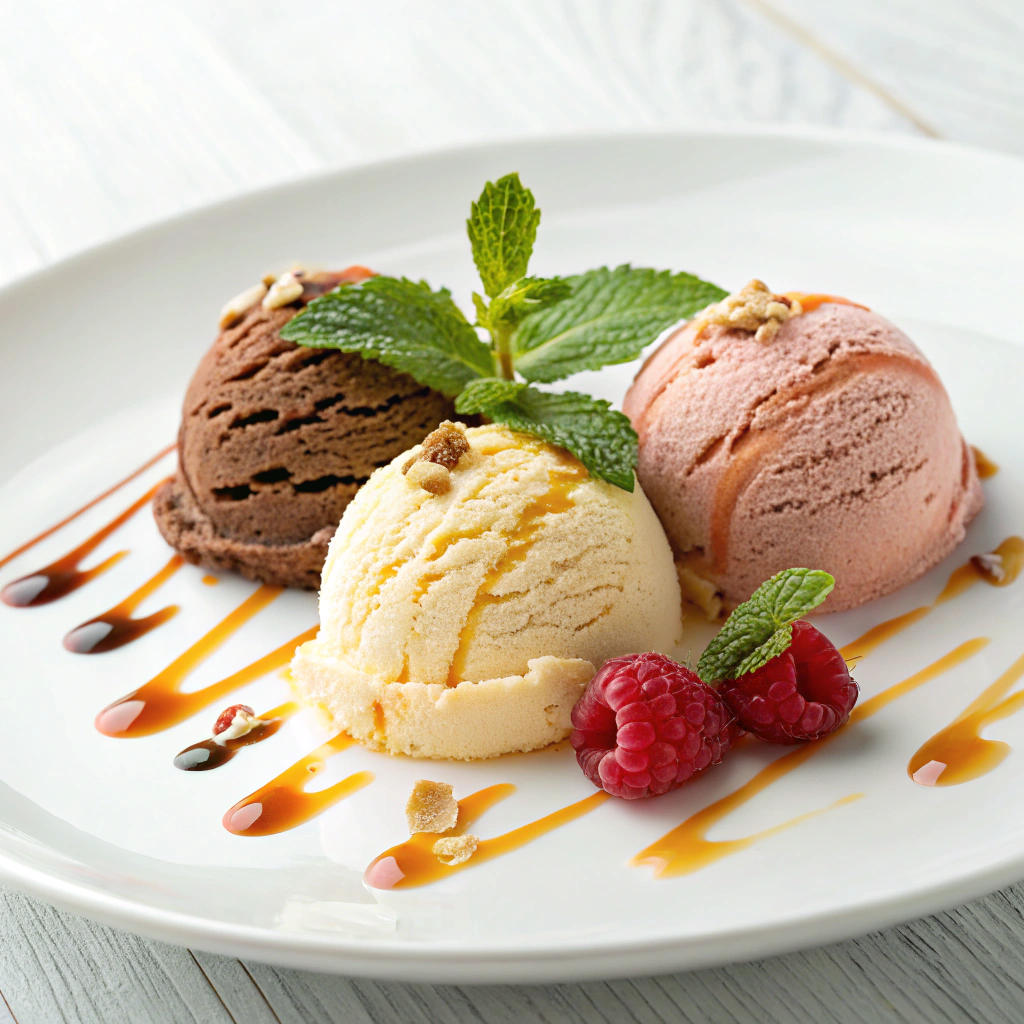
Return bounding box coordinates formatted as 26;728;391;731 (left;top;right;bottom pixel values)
292;426;682;759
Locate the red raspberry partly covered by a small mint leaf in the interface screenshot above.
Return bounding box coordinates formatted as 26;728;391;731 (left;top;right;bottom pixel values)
718;620;860;743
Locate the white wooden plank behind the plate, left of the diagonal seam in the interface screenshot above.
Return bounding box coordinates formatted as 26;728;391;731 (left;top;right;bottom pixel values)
0;0;912;290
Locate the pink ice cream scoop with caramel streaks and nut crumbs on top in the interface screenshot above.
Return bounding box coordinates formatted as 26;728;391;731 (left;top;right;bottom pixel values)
624;292;983;611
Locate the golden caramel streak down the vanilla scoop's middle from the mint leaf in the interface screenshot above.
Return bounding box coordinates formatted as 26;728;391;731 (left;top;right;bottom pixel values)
447;453;587;686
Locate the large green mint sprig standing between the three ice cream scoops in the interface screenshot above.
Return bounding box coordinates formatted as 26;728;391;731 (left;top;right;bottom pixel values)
282;174;725;490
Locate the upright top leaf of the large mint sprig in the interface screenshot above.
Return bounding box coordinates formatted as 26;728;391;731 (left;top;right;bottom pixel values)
466;174;541;298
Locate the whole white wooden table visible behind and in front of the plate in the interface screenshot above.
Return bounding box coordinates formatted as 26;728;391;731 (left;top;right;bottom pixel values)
0;0;1024;1024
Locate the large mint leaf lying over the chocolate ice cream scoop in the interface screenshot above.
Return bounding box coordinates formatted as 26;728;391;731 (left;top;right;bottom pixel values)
281;276;495;396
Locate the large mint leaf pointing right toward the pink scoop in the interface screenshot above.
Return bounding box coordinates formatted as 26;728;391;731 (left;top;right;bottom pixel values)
513;264;727;382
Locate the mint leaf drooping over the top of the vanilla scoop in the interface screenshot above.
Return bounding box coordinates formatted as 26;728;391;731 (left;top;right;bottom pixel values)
455;378;637;490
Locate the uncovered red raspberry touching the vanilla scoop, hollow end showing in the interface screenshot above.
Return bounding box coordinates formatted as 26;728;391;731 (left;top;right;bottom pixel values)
570;654;733;800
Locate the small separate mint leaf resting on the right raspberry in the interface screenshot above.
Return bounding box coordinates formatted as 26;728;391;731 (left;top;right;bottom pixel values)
697;568;836;683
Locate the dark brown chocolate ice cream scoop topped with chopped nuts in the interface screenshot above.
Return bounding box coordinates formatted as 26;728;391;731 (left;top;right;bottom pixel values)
154;267;454;589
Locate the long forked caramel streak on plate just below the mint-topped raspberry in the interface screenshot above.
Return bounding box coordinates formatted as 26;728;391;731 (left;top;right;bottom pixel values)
631;637;989;879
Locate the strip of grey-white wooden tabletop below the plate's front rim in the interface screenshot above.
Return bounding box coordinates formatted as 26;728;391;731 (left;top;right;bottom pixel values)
9;886;1024;1024
